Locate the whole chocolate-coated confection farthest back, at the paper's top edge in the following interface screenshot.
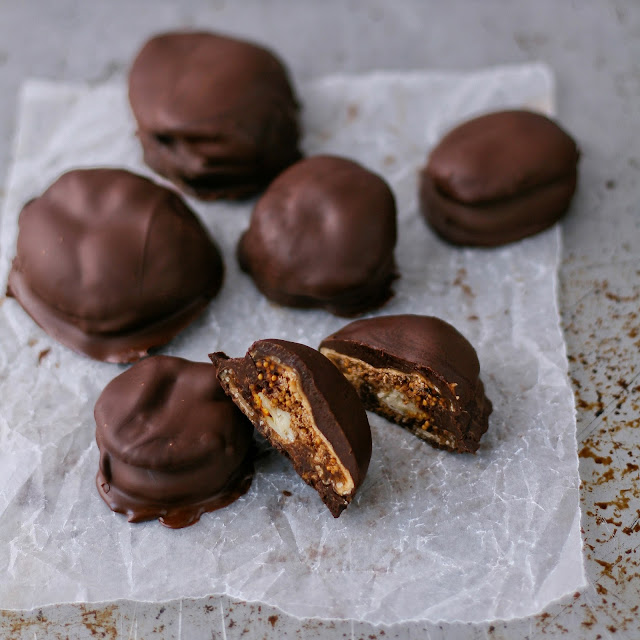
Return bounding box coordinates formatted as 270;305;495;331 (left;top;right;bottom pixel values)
129;32;300;200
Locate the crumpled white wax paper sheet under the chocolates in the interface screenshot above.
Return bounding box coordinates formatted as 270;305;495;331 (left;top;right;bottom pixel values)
0;65;585;624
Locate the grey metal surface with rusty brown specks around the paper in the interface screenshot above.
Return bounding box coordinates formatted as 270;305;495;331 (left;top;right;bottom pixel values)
0;0;640;640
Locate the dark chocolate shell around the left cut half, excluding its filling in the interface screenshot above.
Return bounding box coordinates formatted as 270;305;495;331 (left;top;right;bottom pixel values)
209;339;371;517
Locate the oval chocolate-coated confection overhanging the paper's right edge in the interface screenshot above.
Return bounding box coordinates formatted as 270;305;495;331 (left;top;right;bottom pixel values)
420;110;579;247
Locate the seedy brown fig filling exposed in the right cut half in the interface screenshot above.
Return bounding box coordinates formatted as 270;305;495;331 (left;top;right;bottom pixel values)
320;347;456;450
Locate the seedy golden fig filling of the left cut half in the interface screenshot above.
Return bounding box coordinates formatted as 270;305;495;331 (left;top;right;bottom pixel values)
221;356;354;497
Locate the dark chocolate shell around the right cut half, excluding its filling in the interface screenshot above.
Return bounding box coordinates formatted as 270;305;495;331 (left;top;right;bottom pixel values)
320;314;492;451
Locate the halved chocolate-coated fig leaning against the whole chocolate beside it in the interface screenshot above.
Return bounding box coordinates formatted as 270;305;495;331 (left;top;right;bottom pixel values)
209;340;371;518
